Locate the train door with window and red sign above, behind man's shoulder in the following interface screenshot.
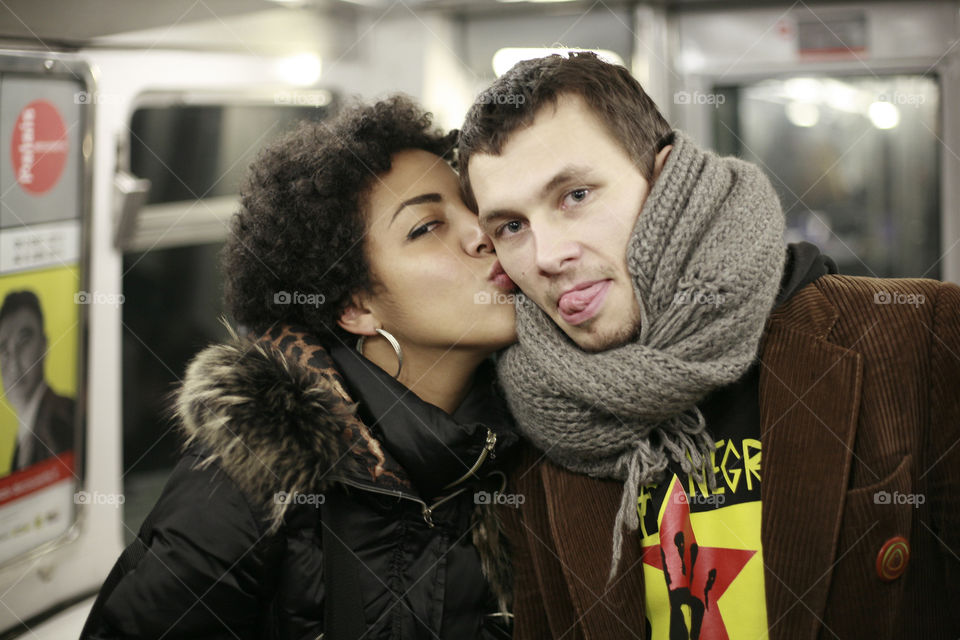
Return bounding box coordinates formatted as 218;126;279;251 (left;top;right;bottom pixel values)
670;2;960;281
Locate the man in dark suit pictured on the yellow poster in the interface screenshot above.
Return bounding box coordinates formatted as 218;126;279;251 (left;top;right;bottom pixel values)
0;291;74;473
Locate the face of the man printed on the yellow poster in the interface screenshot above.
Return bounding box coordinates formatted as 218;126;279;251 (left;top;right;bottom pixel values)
0;309;47;408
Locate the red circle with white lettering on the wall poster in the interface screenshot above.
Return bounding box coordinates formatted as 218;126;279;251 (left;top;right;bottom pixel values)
10;100;70;194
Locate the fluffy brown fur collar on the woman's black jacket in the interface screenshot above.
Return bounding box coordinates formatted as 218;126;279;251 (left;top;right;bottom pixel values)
175;326;412;530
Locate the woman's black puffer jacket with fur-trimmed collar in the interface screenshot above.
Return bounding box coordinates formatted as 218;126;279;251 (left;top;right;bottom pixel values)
82;328;517;640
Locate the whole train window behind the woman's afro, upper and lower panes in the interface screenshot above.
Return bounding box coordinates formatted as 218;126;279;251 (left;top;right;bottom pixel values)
123;92;333;541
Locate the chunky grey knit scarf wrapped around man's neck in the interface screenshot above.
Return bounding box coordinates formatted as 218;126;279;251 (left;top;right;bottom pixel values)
499;131;785;580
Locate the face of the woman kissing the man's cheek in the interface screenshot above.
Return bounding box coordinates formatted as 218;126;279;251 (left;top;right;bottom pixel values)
352;149;516;354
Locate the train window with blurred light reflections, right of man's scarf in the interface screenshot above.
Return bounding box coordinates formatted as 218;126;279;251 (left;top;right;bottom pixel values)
713;75;940;278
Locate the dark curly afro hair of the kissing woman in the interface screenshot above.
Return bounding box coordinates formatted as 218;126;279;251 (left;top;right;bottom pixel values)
221;95;457;344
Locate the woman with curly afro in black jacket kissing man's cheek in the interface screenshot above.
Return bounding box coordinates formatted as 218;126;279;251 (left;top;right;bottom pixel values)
83;97;517;640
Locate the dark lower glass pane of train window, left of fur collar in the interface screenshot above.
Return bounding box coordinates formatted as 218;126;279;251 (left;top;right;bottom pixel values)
123;244;229;542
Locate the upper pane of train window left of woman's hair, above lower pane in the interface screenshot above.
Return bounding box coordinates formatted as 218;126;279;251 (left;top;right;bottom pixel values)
116;90;335;251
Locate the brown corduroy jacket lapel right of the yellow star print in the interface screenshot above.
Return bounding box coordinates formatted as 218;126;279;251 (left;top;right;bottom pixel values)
760;285;862;639
